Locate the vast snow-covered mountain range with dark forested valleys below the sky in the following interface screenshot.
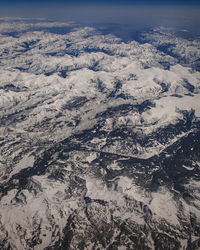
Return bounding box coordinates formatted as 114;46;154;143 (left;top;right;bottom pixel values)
0;18;200;250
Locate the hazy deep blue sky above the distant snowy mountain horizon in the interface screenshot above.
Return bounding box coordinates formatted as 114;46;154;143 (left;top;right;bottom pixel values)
0;0;200;38
